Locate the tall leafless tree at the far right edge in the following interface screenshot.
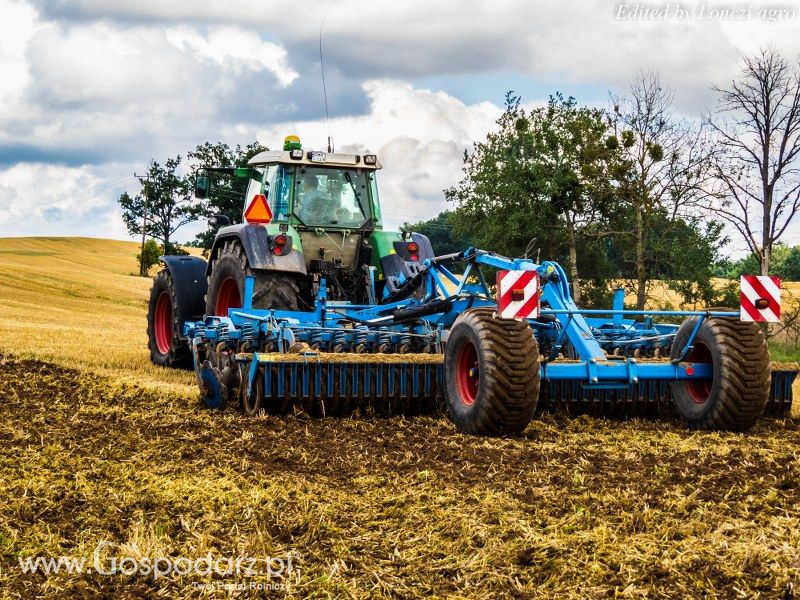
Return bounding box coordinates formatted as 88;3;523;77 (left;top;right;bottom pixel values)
709;49;800;275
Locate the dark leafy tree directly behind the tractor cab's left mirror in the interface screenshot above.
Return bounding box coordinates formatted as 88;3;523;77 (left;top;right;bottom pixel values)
187;141;269;250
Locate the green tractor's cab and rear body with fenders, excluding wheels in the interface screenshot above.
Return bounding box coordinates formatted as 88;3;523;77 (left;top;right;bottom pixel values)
195;136;433;306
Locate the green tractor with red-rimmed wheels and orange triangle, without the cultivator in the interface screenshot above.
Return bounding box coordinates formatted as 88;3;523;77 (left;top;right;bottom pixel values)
148;136;434;368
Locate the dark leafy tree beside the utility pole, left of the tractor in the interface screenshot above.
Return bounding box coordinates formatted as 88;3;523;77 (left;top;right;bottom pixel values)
119;156;202;254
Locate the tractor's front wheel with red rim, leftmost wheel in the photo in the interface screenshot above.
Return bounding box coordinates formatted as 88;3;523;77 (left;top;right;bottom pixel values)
147;269;193;369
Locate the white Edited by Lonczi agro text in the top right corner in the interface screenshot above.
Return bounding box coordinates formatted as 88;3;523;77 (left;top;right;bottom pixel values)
614;2;800;23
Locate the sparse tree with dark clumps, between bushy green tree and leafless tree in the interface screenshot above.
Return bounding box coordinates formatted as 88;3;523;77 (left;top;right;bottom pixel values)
610;72;714;310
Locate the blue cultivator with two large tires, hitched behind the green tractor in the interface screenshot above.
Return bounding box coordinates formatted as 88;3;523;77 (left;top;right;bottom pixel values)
184;248;770;434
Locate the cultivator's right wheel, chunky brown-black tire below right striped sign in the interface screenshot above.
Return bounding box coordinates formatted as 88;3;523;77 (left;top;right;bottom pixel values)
671;317;770;431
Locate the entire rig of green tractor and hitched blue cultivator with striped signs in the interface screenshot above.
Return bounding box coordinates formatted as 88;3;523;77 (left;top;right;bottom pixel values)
148;136;793;434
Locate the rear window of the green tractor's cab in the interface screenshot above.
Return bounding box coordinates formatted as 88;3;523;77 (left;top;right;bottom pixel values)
294;167;369;227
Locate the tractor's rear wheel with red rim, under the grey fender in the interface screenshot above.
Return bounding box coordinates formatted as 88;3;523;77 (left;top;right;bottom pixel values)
206;240;300;316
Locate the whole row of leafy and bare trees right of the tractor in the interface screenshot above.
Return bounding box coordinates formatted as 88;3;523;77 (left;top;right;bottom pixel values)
408;49;800;309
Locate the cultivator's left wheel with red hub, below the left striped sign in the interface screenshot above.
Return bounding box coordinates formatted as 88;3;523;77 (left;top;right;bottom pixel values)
444;308;539;436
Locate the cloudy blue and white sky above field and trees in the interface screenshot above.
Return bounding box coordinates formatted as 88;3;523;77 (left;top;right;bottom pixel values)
0;0;800;253
